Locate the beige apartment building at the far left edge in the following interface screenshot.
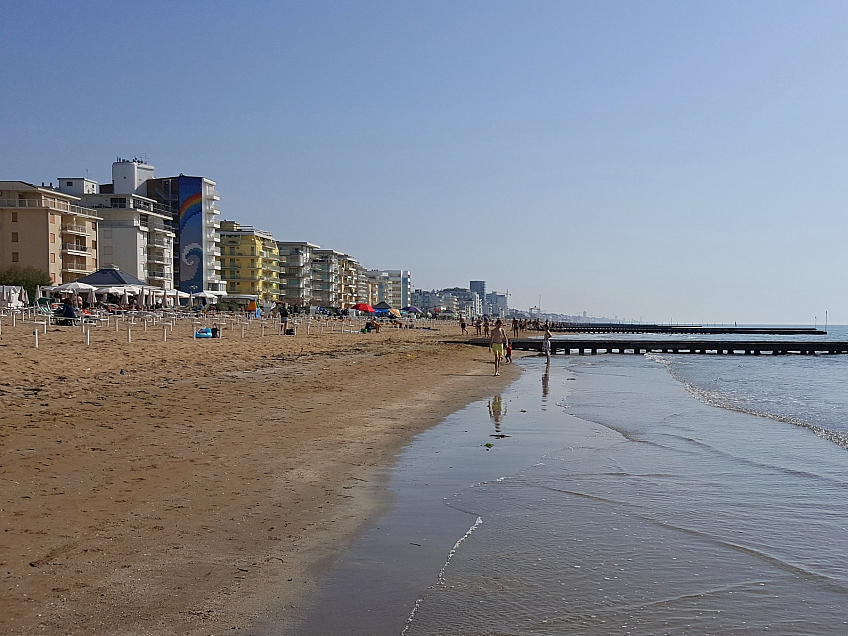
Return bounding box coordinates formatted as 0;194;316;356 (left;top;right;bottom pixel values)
0;181;101;285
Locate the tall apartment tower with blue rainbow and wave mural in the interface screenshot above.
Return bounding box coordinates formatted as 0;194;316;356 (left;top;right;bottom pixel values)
146;171;227;295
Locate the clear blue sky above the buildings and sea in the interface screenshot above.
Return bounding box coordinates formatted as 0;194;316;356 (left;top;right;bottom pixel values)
0;0;848;323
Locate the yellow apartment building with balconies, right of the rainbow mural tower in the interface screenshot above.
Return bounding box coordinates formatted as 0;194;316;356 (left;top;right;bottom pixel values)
218;221;280;302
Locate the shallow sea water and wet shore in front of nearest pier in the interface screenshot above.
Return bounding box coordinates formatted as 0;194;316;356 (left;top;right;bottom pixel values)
284;328;848;636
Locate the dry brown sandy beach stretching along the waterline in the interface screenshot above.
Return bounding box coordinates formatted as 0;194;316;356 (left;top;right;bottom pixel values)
0;318;518;634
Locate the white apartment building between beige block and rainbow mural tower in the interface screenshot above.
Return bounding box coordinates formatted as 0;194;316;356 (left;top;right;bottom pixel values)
59;169;174;289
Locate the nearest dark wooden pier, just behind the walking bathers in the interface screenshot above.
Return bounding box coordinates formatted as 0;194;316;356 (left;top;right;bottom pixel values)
470;338;848;356
